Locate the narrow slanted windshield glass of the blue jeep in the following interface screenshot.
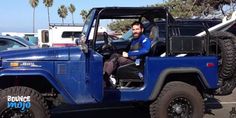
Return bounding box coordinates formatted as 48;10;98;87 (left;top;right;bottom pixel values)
82;10;95;37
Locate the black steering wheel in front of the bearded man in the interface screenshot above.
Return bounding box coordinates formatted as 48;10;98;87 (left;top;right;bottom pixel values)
97;32;117;56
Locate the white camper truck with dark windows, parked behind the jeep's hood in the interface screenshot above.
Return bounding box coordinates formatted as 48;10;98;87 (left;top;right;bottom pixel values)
38;24;83;47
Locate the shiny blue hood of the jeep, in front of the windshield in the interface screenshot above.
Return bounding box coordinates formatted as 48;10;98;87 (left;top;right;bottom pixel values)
0;47;70;61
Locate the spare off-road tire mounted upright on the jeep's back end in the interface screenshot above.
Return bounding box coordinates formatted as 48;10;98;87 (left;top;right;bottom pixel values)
210;32;236;80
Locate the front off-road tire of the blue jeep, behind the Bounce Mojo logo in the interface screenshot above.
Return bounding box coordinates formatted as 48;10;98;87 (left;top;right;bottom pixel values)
0;86;50;118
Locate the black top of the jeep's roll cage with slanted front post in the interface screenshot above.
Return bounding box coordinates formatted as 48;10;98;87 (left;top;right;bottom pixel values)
84;7;174;48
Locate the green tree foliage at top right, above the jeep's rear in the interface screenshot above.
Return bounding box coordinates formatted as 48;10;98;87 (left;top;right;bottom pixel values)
151;0;236;18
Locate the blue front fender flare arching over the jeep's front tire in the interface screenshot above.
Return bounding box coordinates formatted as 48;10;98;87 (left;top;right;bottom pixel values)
0;68;75;104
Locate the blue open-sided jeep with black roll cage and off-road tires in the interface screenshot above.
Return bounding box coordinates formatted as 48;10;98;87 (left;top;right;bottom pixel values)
0;7;222;118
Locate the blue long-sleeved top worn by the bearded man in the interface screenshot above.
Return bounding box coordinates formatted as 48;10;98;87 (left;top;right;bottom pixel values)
128;34;151;57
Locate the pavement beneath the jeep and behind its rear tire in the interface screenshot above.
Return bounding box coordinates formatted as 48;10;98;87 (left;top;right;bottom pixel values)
53;89;236;118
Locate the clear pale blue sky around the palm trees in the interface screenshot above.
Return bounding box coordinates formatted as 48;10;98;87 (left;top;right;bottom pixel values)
0;0;163;32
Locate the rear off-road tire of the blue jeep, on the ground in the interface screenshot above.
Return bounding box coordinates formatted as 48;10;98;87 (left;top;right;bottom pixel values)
149;81;204;118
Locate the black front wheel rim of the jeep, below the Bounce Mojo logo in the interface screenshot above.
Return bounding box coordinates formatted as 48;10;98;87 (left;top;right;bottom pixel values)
1;108;34;118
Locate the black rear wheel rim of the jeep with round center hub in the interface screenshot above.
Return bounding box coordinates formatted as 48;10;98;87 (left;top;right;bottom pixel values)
168;97;193;118
